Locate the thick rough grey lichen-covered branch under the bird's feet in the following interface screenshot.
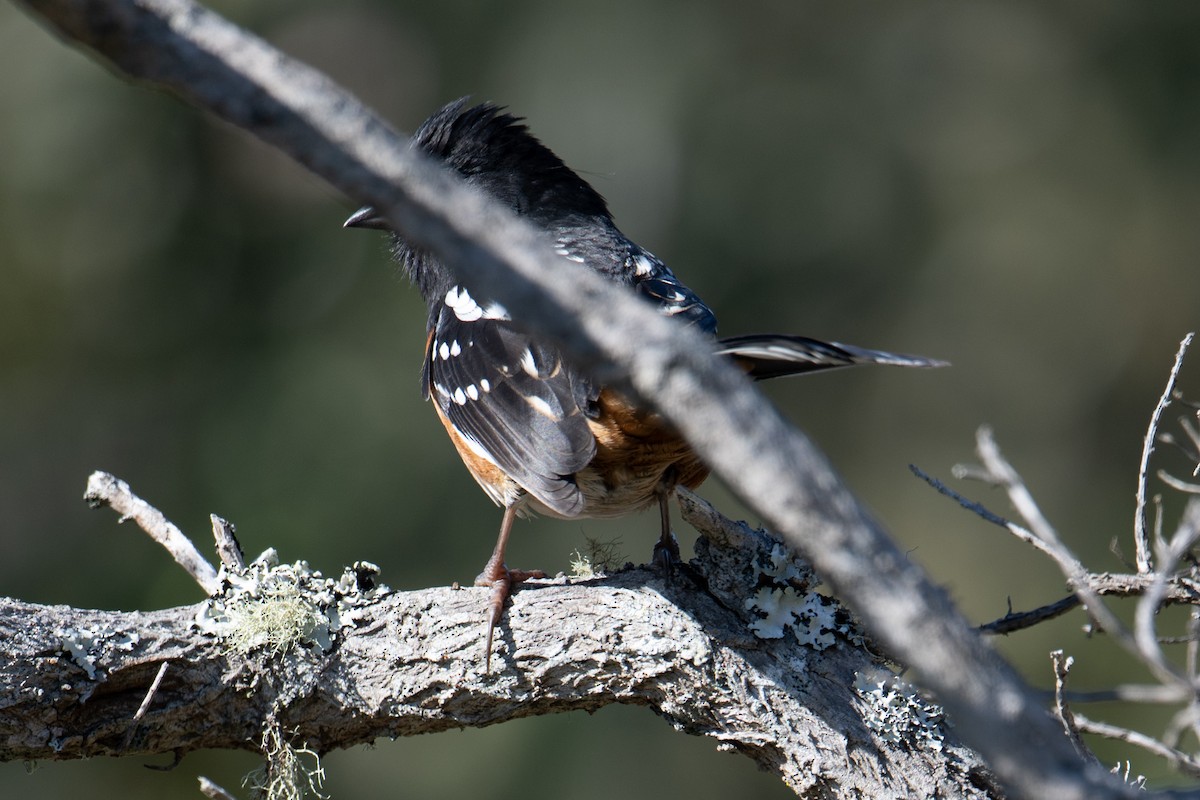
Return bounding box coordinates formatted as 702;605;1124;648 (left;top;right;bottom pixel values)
0;489;998;798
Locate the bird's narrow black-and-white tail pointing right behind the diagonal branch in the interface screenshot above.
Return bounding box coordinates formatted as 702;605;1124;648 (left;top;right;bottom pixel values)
716;333;949;380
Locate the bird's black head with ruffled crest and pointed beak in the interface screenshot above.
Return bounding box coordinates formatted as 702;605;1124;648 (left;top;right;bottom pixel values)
346;97;612;307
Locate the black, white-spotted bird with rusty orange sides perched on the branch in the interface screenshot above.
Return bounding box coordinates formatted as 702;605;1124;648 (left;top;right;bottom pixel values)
344;98;942;670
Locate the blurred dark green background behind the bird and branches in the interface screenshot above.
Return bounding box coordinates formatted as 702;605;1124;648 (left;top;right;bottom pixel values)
0;0;1200;800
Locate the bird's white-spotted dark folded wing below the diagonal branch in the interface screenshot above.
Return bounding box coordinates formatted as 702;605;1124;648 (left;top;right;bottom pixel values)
426;306;595;516
